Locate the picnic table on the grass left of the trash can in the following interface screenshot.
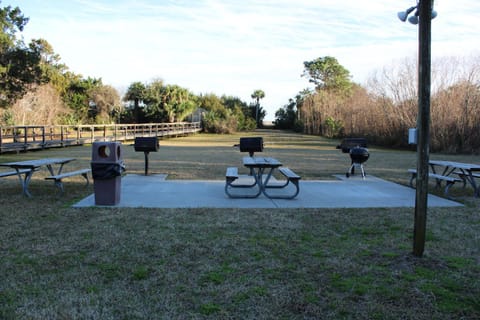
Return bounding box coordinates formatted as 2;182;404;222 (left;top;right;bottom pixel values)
0;158;79;197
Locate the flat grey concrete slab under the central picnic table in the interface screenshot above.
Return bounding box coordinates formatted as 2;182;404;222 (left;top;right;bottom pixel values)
73;174;462;208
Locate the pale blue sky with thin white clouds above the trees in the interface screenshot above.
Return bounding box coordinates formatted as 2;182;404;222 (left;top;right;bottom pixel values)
6;0;480;120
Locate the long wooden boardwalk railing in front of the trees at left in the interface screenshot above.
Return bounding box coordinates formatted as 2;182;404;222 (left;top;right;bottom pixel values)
0;122;201;153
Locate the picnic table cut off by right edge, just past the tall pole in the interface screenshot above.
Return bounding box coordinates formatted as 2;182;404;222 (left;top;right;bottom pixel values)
429;160;480;197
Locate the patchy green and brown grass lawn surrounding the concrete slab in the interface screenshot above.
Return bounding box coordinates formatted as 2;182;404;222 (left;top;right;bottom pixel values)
0;131;480;319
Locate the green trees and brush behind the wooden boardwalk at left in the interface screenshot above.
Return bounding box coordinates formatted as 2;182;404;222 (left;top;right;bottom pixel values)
0;1;266;133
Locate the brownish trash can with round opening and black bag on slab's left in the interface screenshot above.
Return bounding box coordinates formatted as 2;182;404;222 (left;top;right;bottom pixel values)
91;142;125;205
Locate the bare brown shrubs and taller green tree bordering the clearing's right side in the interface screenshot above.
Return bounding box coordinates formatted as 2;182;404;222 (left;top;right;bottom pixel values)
275;56;480;153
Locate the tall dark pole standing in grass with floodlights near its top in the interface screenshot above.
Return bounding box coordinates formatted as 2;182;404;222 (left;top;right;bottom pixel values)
413;0;433;257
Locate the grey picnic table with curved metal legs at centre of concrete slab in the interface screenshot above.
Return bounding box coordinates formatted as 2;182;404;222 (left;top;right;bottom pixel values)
225;157;300;199
